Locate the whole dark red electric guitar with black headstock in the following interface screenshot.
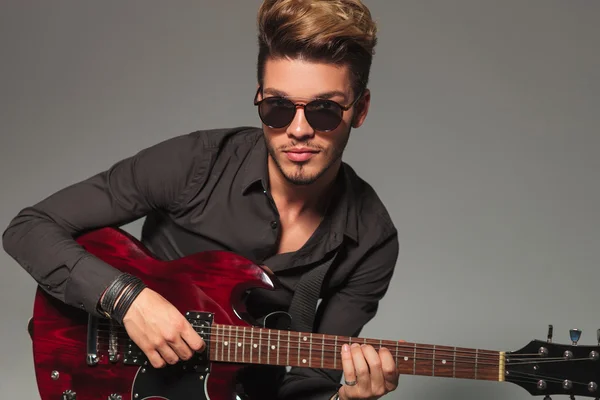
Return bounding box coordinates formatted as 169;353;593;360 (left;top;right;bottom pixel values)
29;228;600;400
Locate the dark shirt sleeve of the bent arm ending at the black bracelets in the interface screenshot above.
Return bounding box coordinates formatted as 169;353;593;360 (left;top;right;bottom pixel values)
2;135;206;315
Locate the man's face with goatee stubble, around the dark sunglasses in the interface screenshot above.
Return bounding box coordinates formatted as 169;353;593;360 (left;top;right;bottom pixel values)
258;59;369;185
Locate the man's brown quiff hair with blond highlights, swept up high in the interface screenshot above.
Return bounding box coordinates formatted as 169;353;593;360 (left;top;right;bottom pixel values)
257;0;377;95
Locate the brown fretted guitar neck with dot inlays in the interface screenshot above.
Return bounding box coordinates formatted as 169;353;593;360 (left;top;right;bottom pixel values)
209;324;504;381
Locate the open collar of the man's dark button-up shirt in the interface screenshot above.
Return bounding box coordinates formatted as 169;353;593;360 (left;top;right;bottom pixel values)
241;135;359;242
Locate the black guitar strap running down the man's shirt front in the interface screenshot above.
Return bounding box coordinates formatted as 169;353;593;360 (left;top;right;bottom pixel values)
288;252;337;332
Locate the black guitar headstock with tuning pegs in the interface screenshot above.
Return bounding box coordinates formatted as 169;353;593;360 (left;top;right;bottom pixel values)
505;325;600;399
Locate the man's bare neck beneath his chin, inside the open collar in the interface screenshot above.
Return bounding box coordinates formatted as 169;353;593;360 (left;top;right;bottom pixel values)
268;157;341;214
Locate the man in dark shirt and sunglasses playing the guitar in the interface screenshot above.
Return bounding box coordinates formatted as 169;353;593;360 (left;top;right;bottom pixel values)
3;0;398;400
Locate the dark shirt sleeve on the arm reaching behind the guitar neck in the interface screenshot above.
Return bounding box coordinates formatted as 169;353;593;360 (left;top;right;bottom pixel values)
277;231;399;400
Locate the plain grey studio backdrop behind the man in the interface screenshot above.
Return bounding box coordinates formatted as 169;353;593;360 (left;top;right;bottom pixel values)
0;0;600;400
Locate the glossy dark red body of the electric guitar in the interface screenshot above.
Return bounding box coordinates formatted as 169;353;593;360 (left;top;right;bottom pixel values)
30;228;274;400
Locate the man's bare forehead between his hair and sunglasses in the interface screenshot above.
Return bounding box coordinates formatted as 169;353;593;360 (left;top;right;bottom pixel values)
263;59;351;98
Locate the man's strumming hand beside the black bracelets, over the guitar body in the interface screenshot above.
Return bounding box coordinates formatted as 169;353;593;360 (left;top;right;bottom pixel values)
123;288;205;368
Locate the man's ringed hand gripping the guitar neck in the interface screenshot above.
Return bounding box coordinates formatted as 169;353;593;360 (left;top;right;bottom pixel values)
338;343;399;400
